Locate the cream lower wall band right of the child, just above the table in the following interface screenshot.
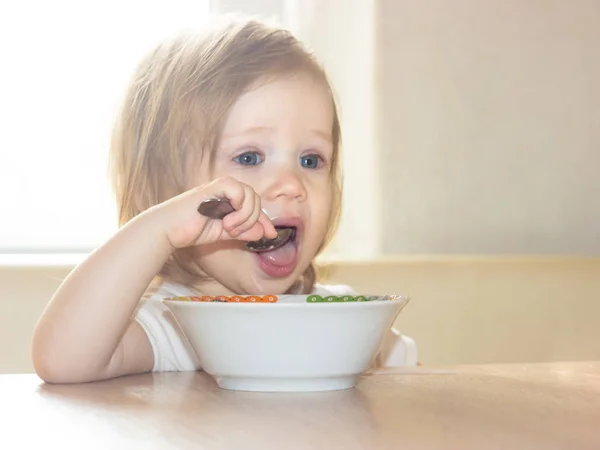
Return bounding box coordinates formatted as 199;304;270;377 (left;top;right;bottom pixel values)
324;256;600;365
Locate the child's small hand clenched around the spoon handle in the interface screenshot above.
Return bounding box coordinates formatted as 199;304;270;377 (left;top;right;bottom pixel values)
154;177;277;248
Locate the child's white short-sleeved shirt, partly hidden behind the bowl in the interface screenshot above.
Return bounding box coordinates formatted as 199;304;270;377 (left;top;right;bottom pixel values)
135;282;417;372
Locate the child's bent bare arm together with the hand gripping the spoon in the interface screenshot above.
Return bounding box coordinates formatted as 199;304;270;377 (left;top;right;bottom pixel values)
32;178;276;383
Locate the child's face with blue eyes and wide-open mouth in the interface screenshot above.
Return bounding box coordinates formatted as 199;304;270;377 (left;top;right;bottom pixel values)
194;76;334;294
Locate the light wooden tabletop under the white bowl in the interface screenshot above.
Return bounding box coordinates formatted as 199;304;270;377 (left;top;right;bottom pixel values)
0;362;600;450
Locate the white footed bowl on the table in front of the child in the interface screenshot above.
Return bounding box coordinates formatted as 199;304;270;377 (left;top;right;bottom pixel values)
163;295;409;392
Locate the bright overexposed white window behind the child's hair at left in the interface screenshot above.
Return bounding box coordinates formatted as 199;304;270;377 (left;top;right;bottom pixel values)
0;0;209;253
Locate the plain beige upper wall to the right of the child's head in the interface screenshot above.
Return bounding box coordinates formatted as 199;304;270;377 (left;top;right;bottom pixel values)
378;0;600;255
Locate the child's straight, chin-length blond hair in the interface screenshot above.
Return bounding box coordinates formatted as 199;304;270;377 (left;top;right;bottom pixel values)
110;18;342;292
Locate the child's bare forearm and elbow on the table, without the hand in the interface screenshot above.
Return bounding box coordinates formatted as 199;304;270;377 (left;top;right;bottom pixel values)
32;214;171;382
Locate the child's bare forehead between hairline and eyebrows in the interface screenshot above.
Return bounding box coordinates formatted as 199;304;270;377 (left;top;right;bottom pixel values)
222;74;334;139
